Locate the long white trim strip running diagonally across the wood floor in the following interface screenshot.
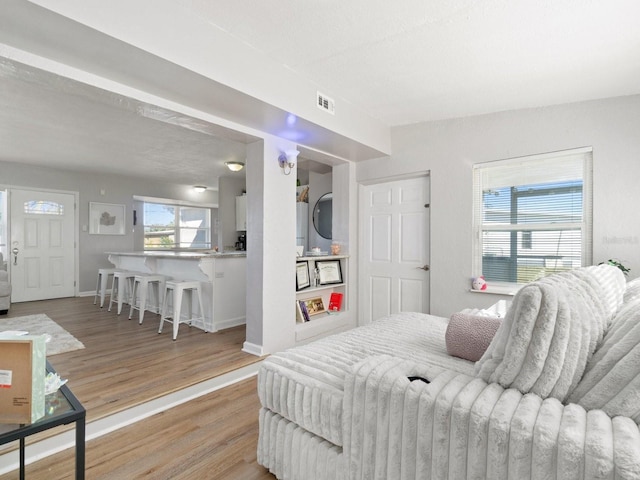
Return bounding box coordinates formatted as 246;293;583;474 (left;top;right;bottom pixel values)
0;361;261;475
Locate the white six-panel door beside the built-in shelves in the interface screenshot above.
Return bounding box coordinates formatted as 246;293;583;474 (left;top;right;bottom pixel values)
360;175;429;324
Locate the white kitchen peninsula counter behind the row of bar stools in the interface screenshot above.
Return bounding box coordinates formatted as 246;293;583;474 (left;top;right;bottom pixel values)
107;251;247;332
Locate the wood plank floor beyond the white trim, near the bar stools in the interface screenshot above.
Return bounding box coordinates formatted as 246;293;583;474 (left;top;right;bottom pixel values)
0;297;260;421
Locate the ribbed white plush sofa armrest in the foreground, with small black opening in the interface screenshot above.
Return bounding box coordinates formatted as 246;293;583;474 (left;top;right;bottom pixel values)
343;356;640;480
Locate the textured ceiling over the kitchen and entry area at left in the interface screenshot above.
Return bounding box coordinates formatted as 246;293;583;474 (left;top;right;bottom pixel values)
0;59;246;187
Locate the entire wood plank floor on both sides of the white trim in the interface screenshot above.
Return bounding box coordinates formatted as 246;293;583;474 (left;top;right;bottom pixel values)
0;297;273;480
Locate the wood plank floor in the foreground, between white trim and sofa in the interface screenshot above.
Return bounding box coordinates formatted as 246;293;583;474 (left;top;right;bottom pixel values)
0;377;275;480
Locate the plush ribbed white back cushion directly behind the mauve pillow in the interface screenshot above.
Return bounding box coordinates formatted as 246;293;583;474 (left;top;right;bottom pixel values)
476;265;625;401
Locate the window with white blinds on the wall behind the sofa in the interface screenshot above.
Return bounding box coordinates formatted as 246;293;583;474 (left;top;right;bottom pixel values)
473;148;592;284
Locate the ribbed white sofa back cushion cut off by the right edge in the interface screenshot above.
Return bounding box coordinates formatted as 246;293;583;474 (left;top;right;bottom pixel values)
569;282;640;423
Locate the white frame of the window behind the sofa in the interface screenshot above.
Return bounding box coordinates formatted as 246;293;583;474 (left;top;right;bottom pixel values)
472;147;593;293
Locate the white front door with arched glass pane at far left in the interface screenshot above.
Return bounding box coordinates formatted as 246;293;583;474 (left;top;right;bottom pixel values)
7;189;76;302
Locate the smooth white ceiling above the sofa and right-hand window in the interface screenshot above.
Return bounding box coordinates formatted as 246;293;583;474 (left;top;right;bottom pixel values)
188;0;640;125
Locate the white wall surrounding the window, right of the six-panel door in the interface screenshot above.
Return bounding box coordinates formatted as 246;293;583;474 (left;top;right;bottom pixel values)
357;95;640;316
